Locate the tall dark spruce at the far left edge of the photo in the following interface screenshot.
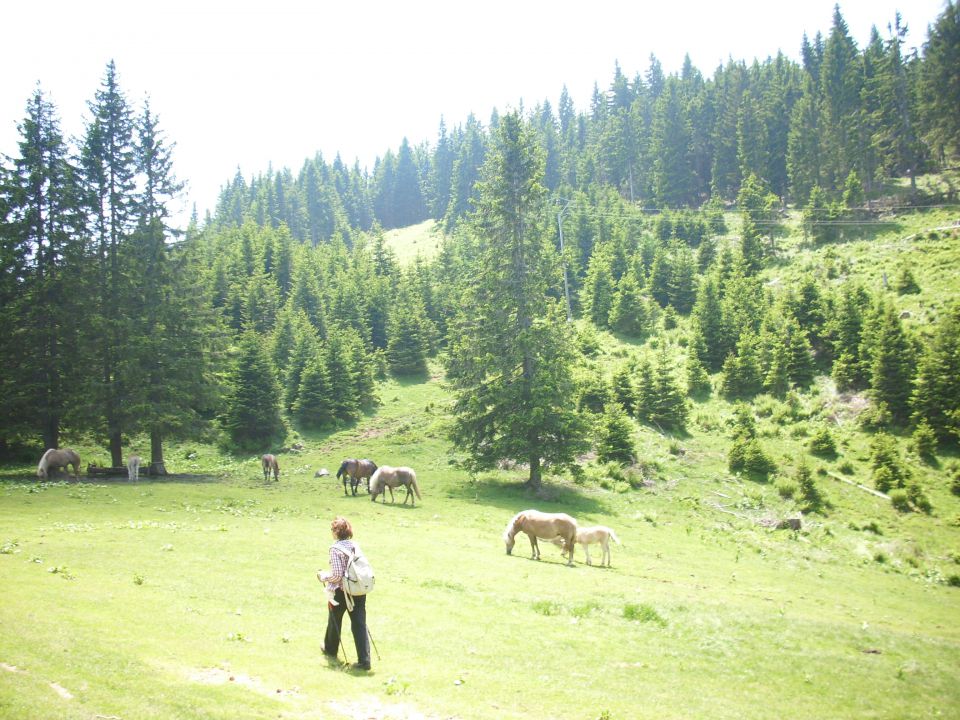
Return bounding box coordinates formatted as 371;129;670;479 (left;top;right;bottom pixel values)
0;88;90;448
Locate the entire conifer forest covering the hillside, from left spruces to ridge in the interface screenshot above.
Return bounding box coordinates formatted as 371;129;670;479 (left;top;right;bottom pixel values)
0;1;960;490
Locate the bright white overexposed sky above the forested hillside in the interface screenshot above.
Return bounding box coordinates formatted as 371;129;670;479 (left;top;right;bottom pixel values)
0;0;944;225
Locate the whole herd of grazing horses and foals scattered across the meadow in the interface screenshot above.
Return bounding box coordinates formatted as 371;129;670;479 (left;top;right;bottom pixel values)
37;448;620;567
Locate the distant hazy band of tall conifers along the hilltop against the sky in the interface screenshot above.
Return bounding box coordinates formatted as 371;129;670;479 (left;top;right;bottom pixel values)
214;2;960;243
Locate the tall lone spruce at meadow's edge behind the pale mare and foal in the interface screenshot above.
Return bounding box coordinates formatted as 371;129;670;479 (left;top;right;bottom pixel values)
447;113;583;488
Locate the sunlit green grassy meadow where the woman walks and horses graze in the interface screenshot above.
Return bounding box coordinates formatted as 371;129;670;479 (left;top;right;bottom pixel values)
0;362;960;720
